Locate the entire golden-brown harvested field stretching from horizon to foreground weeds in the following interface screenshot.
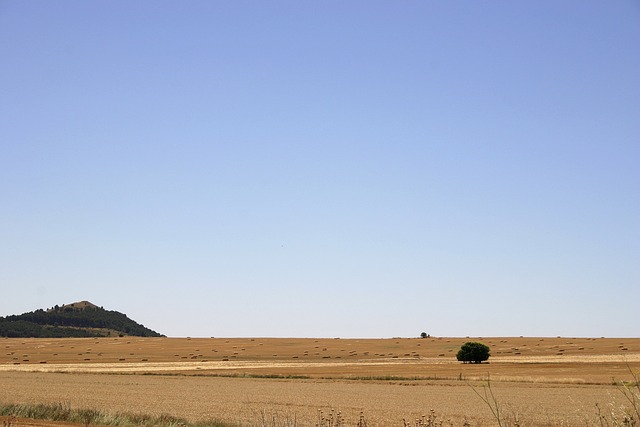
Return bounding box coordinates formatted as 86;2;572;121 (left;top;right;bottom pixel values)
0;337;640;427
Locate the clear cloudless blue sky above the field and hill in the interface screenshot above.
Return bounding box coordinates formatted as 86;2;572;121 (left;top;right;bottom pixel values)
0;0;640;337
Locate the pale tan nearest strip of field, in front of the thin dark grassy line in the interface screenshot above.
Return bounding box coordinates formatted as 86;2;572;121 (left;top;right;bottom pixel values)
0;373;639;427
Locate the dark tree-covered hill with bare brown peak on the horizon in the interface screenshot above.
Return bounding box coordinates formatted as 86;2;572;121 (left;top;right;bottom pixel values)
0;301;163;338
